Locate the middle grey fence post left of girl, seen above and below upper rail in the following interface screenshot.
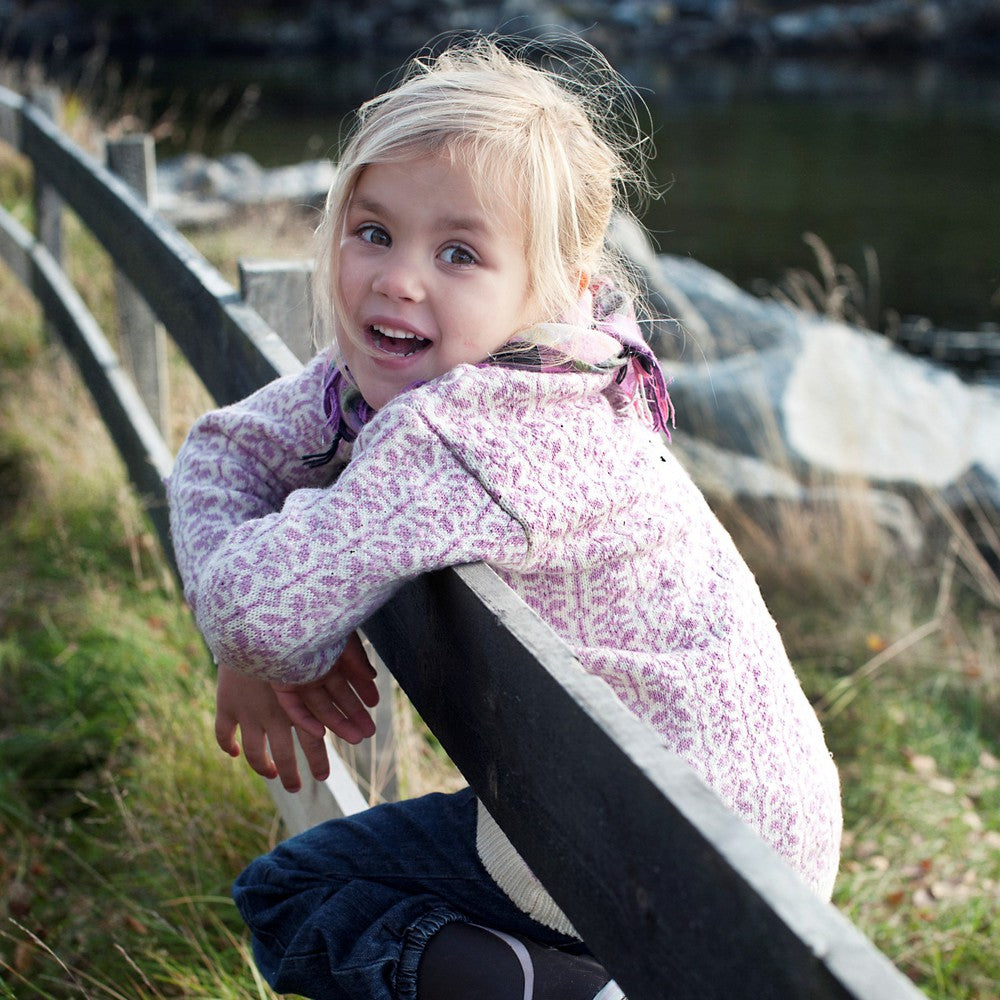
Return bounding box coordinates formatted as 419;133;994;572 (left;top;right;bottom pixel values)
105;135;170;438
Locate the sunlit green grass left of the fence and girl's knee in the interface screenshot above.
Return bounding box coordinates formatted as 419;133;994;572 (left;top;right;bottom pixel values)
0;256;275;1000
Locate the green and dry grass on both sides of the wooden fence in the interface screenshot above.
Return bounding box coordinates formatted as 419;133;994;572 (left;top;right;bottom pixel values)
0;164;1000;1000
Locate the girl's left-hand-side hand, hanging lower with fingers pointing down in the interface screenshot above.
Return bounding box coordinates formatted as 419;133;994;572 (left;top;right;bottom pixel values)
215;664;330;792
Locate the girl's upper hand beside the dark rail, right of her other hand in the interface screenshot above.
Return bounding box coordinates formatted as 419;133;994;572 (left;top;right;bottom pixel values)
271;633;378;743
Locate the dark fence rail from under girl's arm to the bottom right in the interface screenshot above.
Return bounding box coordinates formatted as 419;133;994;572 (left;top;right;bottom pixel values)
365;566;920;1000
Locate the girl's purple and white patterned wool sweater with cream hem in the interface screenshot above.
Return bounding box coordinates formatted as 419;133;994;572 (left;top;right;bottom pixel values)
169;357;841;928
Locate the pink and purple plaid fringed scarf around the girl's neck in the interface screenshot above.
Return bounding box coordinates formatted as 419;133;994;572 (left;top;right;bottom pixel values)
302;280;674;468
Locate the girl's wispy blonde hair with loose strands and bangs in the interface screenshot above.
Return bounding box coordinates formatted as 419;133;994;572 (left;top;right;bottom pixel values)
314;35;650;352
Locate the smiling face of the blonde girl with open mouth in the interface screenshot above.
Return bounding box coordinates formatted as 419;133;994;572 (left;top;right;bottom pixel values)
338;154;531;409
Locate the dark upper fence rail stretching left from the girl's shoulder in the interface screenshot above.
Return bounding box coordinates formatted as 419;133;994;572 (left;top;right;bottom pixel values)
11;94;301;403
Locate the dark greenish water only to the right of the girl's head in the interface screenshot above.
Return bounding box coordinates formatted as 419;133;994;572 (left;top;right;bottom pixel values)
632;56;1000;328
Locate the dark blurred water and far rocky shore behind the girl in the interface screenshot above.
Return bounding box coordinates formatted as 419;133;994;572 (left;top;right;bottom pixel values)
0;0;1000;330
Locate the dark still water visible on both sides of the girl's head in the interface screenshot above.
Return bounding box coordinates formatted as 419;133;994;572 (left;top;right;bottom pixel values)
125;49;1000;329
